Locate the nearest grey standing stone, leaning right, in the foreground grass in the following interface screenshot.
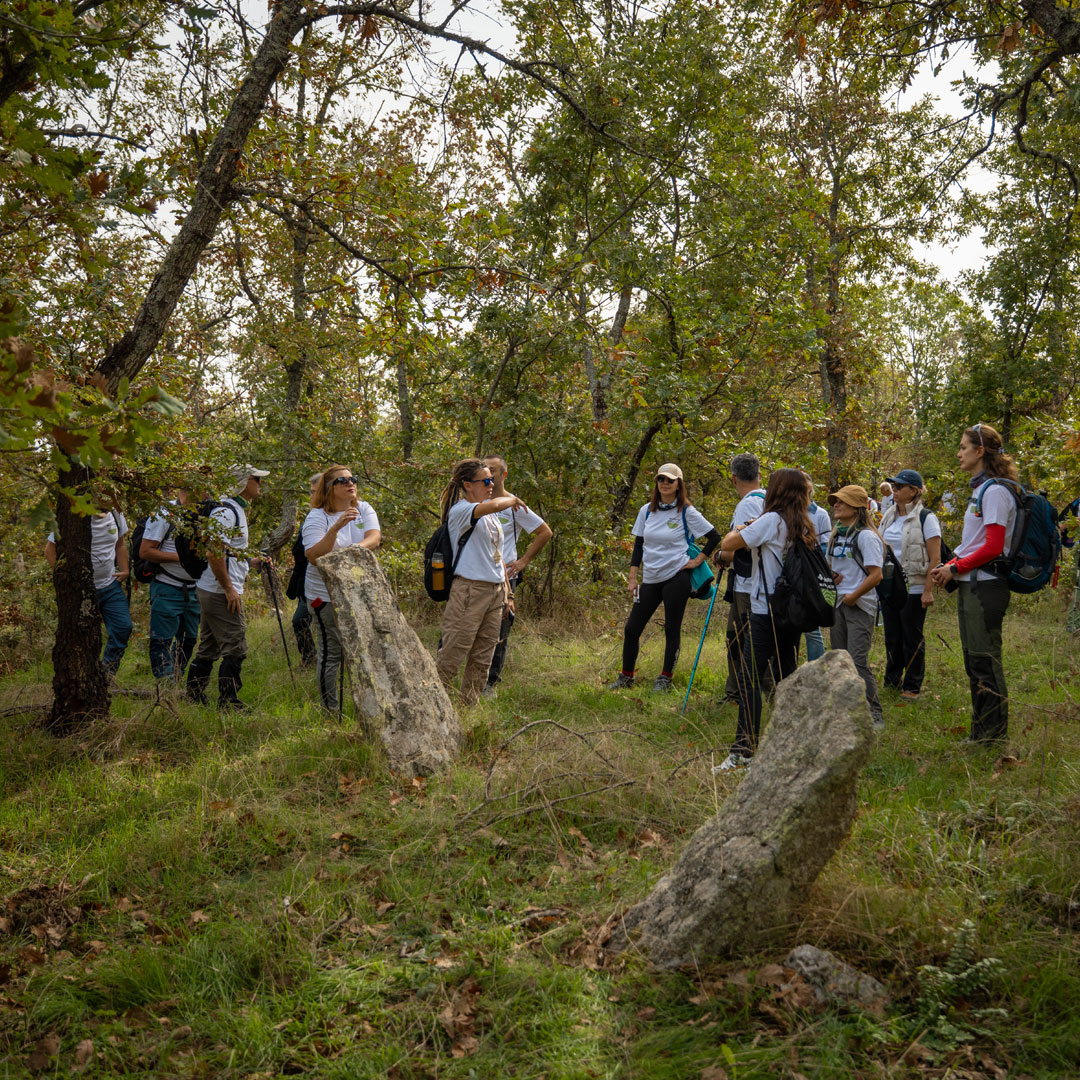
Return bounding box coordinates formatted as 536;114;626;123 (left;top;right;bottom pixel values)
608;651;874;968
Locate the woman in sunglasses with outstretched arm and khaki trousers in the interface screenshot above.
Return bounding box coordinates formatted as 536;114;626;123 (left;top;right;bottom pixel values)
435;458;525;705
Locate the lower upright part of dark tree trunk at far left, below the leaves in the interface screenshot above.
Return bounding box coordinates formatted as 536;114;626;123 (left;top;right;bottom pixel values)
45;462;110;735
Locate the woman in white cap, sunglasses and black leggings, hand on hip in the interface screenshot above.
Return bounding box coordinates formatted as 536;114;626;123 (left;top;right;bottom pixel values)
609;464;720;691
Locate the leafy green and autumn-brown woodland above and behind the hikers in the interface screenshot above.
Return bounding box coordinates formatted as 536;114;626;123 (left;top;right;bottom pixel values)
6;0;1080;665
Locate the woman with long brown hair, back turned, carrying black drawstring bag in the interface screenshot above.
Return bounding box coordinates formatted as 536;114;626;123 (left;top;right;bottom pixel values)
719;469;818;770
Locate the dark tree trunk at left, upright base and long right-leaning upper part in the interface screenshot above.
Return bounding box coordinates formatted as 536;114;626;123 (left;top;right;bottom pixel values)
49;0;310;731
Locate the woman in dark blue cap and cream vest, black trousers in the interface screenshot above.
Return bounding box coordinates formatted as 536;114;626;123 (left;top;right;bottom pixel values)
881;469;942;702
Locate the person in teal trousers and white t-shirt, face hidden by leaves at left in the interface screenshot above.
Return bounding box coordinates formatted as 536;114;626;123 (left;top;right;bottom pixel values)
138;488;202;683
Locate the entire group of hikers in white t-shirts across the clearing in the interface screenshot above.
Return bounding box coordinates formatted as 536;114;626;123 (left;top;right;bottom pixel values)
45;424;1016;751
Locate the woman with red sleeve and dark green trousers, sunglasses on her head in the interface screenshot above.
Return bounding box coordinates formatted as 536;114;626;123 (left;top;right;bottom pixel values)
930;423;1020;743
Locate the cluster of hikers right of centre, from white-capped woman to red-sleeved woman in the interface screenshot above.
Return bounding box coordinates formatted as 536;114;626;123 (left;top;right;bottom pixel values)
611;423;1017;771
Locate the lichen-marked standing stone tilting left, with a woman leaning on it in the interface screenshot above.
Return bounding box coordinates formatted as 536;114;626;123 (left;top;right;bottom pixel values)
319;546;461;777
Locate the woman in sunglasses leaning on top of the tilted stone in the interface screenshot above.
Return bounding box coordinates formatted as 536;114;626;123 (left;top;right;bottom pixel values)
302;465;382;713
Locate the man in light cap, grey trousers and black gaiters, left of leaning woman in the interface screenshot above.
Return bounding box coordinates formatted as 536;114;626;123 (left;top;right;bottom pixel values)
187;464;270;711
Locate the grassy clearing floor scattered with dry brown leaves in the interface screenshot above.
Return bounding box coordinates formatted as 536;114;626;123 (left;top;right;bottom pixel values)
0;596;1080;1080
